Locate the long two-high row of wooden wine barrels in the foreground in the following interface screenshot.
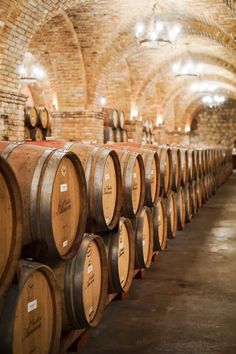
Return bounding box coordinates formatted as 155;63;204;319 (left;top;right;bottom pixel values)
0;141;231;354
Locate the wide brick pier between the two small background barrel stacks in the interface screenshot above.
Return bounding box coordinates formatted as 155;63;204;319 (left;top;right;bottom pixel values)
51;110;104;143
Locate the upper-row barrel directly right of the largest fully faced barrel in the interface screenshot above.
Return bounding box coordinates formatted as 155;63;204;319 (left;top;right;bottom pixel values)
25;140;122;233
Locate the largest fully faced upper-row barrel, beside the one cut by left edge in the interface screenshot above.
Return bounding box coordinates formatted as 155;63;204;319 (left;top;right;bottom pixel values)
0;142;87;259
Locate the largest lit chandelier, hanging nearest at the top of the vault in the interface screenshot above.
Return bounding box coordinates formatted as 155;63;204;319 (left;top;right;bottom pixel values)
135;2;182;47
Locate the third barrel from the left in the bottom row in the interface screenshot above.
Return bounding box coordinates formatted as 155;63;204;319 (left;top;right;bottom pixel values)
102;218;135;293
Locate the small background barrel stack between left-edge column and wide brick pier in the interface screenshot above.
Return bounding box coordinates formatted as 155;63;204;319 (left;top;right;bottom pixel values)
24;106;51;141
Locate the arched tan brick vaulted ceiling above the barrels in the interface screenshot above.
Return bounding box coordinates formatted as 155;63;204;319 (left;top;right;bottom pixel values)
0;0;236;130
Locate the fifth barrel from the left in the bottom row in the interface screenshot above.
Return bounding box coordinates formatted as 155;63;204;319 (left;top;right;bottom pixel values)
152;198;167;251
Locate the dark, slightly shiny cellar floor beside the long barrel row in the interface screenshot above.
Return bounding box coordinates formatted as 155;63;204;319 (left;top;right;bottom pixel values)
80;174;236;354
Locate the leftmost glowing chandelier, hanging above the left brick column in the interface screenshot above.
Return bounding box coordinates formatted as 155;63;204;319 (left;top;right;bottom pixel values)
18;52;46;84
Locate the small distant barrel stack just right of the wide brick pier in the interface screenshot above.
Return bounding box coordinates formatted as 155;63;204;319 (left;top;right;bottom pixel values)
103;108;128;143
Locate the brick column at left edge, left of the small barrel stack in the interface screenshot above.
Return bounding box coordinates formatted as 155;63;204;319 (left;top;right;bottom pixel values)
0;90;27;141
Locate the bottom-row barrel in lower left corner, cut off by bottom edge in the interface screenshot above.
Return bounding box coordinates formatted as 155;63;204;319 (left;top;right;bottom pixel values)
0;261;61;354
